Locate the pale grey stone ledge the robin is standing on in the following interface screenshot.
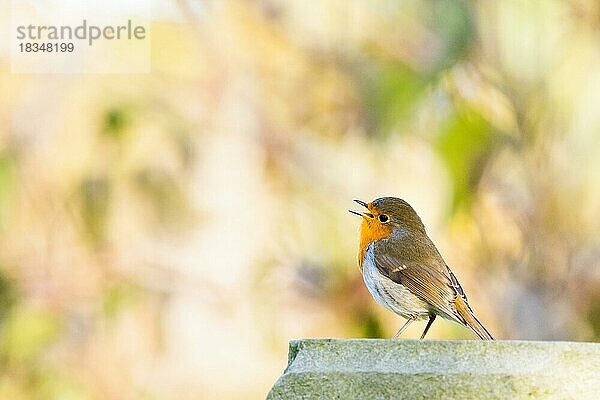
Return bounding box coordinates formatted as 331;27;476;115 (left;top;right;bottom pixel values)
267;339;600;400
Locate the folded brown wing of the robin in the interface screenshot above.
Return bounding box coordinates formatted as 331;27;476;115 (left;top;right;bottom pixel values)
374;241;463;322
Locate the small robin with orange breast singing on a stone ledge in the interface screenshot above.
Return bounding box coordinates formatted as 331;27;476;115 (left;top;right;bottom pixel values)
348;197;494;340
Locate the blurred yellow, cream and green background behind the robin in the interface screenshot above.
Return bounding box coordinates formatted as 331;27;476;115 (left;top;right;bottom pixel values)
0;0;600;400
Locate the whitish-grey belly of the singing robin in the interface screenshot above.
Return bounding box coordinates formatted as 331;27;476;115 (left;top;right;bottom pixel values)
362;244;430;319
